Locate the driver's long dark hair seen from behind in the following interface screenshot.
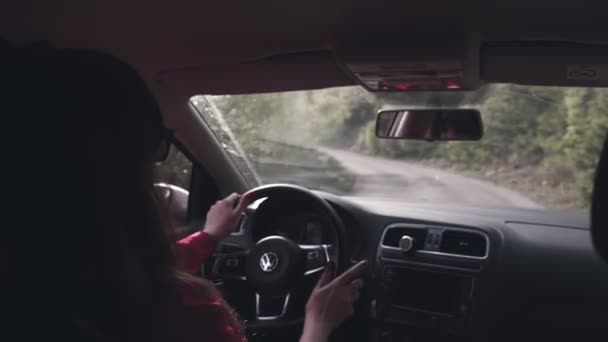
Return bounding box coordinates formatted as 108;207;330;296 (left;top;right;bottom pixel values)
0;44;173;341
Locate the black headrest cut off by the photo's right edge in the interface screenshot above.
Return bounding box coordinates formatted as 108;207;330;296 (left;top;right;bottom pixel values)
591;137;608;262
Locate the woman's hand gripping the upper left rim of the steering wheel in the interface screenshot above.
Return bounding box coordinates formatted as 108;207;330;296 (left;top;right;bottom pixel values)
203;193;250;240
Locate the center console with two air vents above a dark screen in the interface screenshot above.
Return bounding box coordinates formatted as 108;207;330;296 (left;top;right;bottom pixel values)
371;224;490;341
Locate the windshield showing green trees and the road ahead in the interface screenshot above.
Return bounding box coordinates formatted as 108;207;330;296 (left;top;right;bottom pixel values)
191;84;608;209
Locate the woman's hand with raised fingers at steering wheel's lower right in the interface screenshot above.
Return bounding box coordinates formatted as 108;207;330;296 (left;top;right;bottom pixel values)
301;260;367;342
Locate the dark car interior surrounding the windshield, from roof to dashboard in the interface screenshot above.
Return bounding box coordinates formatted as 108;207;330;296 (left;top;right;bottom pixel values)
0;0;608;342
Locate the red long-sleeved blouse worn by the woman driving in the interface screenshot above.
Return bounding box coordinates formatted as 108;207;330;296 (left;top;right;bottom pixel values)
175;232;245;342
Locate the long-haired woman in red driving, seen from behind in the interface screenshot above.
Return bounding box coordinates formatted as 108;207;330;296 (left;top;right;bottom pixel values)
2;44;366;342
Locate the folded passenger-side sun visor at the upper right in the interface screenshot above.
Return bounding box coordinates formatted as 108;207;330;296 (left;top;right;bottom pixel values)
480;42;608;87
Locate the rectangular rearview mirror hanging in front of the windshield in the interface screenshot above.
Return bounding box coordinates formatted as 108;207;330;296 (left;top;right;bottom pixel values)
376;109;483;141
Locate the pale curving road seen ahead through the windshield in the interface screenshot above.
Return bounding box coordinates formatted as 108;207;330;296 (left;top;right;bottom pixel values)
320;148;541;208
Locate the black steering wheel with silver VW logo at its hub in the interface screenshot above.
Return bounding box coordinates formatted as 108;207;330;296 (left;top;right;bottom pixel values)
212;184;347;328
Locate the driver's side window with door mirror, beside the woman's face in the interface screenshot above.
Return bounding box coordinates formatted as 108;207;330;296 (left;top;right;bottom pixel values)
156;146;192;237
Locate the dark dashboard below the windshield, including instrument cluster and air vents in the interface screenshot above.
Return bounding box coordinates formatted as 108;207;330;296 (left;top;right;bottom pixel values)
217;192;608;342
